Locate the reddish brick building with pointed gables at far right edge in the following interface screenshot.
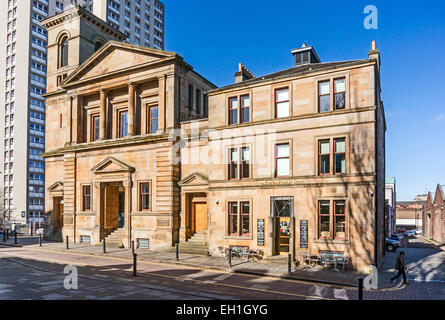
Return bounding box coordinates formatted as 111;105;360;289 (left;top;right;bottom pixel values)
424;184;445;243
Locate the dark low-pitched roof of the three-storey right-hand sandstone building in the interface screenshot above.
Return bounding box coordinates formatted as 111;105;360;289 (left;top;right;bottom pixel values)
209;59;375;93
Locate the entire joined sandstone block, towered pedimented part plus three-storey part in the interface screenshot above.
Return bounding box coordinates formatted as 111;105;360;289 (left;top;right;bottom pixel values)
44;8;386;269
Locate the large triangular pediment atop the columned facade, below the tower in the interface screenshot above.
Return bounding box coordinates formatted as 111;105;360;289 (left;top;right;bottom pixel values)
61;41;182;87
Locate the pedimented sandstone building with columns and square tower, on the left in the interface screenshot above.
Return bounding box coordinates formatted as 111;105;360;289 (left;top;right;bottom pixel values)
43;7;215;248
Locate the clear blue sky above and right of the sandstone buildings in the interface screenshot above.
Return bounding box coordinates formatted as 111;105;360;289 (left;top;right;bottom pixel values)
164;0;445;200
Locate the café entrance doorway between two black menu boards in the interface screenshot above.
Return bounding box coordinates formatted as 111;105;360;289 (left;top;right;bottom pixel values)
270;197;294;255
